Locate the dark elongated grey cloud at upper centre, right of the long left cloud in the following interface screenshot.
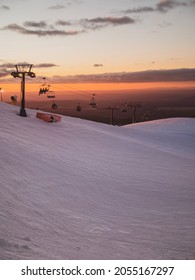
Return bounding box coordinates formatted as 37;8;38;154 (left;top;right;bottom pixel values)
80;16;135;29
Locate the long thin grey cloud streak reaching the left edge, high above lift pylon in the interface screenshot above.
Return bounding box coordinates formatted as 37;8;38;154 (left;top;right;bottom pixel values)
1;23;84;37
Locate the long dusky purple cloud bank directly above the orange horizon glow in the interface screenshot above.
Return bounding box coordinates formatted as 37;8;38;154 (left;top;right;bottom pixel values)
51;68;195;83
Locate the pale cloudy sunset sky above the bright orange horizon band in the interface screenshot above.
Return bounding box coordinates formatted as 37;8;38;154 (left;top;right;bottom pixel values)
0;0;195;95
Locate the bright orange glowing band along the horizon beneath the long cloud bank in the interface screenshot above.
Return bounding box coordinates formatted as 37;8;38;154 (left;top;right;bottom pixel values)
1;82;195;101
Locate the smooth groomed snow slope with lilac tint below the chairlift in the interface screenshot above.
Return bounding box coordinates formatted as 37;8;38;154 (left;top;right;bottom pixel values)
0;103;195;260
